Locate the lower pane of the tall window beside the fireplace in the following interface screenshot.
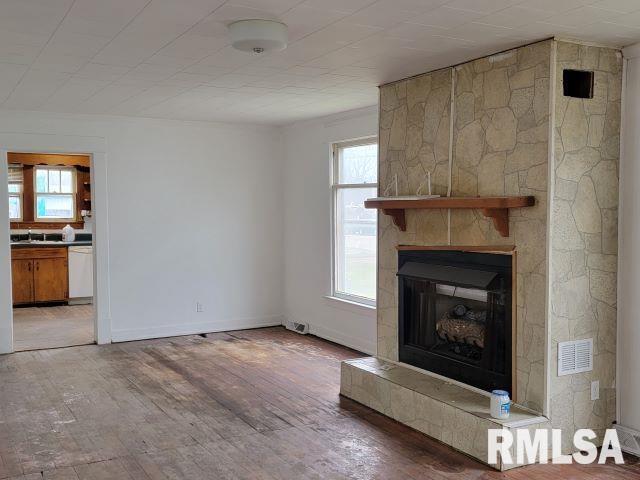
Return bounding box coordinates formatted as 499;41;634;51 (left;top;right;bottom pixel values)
335;188;377;300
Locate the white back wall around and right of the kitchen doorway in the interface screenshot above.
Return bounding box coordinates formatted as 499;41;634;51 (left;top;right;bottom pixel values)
0;111;284;341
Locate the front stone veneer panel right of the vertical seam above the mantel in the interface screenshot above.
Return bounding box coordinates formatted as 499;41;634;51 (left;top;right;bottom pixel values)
451;41;552;412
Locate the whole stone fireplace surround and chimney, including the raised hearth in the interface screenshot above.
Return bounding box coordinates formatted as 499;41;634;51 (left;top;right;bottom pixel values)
341;40;622;469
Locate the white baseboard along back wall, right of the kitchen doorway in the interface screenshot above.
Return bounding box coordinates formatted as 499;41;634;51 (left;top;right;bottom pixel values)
111;315;284;343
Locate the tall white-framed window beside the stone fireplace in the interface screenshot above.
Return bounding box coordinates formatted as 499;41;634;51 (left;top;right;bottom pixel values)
332;138;378;305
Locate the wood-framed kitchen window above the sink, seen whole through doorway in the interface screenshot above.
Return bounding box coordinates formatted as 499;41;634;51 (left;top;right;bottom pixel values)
34;166;76;222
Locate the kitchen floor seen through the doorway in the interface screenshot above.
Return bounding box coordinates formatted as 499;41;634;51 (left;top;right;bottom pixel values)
13;305;94;352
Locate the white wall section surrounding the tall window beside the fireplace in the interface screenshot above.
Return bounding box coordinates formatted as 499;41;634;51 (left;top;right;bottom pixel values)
284;107;378;353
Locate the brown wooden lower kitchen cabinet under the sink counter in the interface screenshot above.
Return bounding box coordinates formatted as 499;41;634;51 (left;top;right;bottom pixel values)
11;247;69;305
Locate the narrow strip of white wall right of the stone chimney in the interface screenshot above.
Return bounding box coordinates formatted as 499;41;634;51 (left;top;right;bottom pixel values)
617;44;640;430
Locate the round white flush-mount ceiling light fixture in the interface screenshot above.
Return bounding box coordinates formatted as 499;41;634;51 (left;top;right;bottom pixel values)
228;19;288;53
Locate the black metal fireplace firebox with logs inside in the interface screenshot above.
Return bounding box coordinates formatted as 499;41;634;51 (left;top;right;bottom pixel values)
398;250;513;393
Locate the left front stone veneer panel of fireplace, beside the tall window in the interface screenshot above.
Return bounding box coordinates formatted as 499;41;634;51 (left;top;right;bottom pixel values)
377;69;451;360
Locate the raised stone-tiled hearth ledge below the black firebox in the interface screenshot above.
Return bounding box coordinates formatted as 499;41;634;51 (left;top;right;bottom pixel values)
340;357;549;470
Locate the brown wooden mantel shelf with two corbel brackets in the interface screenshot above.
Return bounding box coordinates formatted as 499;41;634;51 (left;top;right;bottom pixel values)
364;196;536;237
